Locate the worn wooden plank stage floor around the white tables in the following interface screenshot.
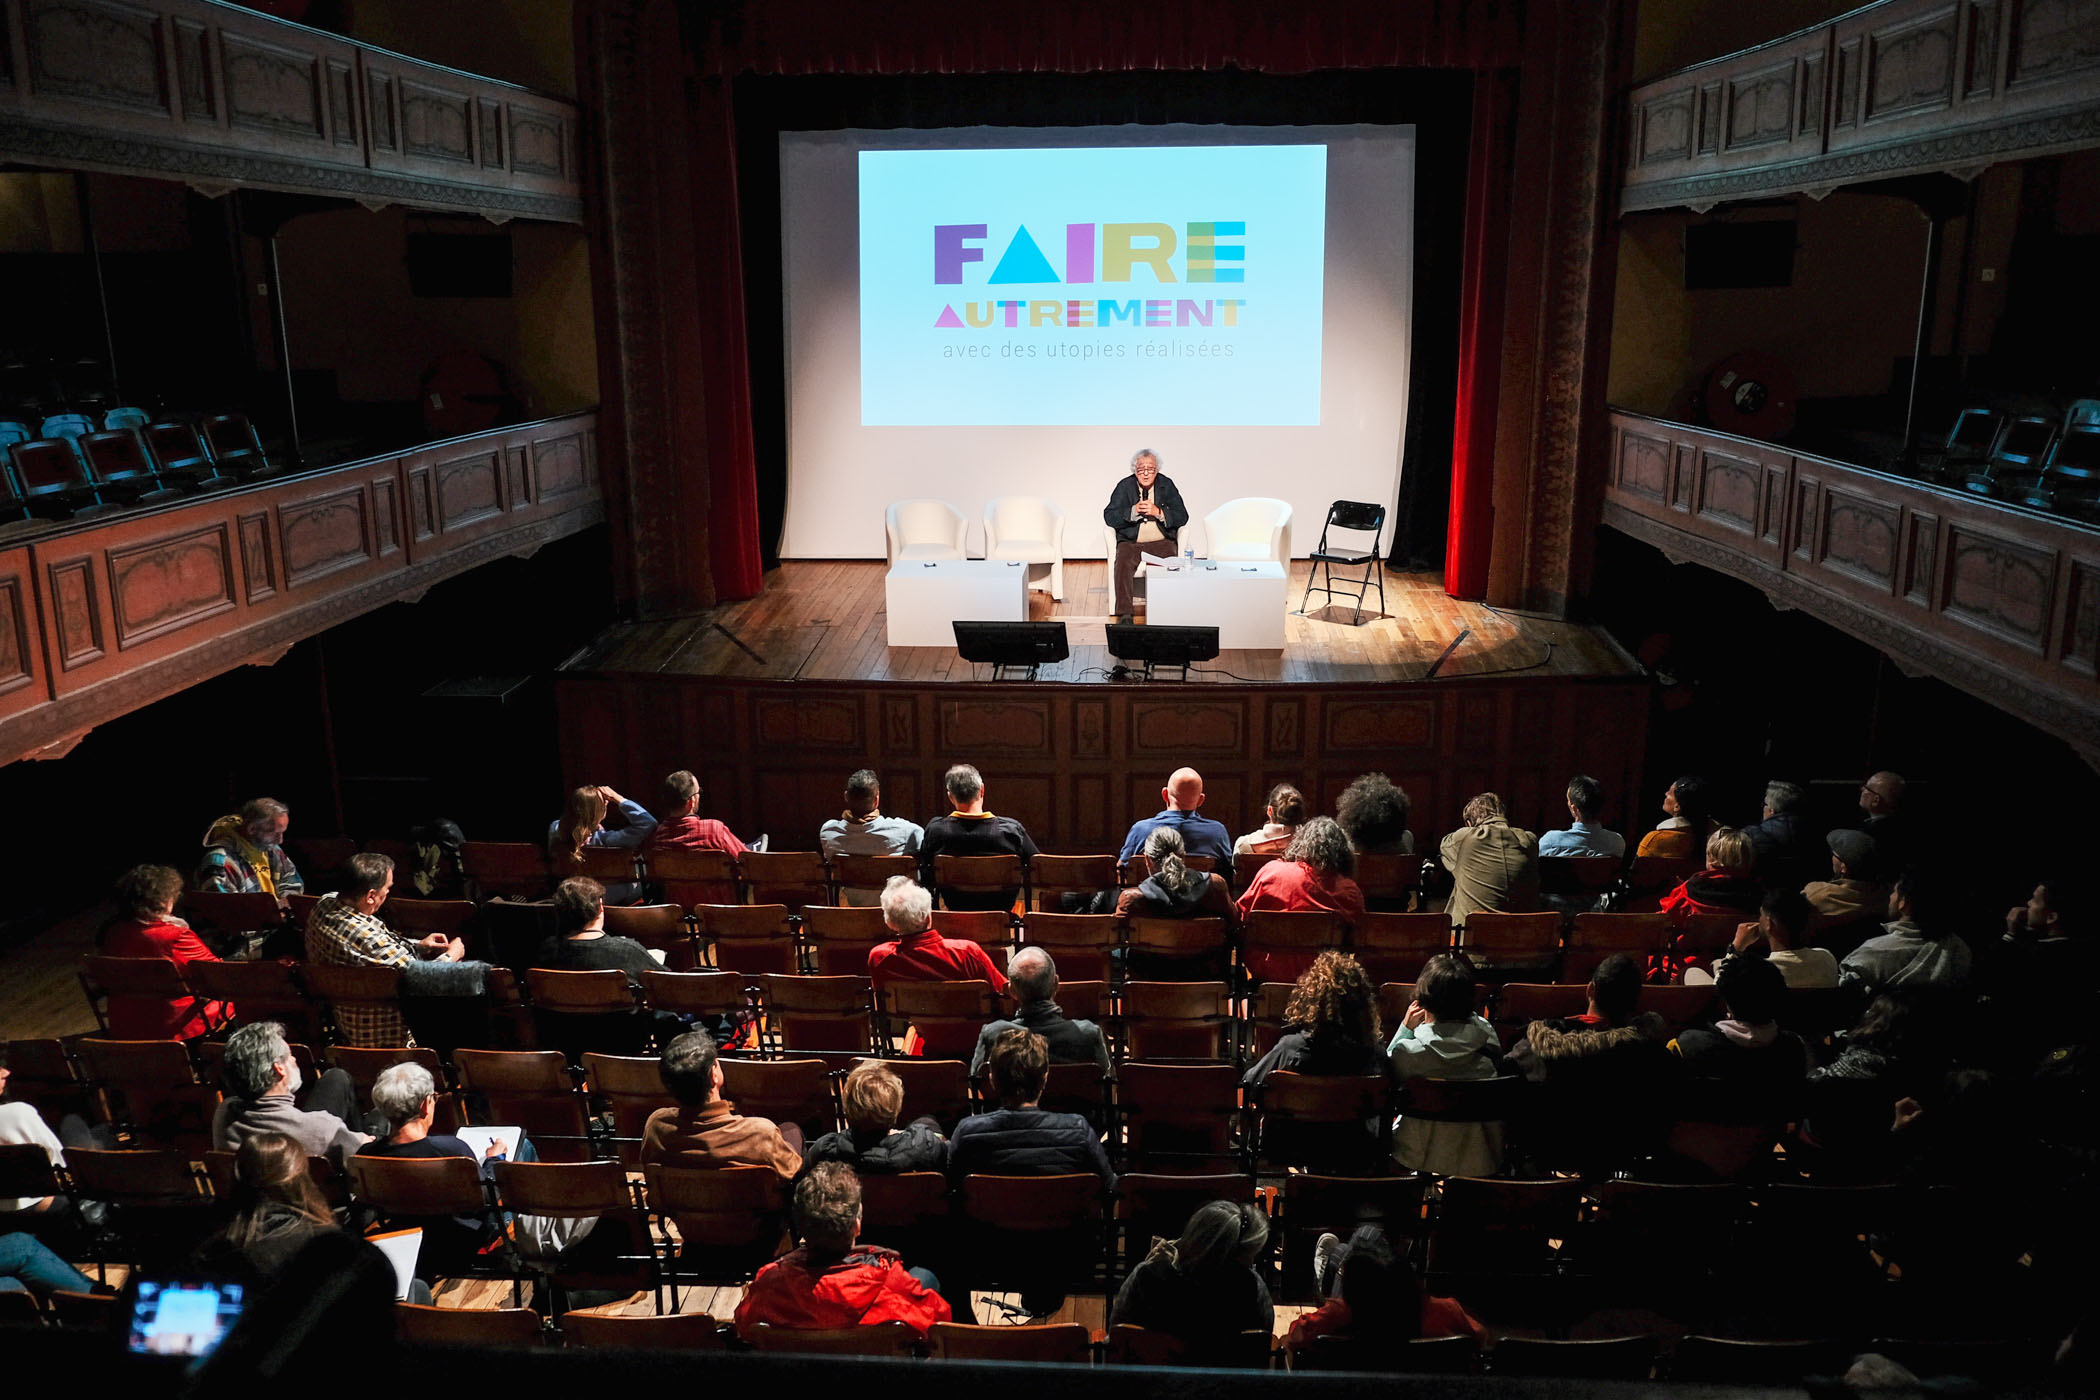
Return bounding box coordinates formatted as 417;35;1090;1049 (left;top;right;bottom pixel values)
563;560;1640;684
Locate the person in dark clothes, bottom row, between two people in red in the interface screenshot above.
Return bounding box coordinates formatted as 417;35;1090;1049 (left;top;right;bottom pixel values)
1109;1201;1277;1366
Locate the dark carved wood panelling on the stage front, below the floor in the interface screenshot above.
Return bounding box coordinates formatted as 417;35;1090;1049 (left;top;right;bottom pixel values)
554;670;1653;852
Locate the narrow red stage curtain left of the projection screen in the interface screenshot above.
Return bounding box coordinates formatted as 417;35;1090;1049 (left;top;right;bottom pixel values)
687;78;764;598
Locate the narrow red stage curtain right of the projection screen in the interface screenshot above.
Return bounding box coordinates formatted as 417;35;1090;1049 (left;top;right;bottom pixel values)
1445;73;1516;598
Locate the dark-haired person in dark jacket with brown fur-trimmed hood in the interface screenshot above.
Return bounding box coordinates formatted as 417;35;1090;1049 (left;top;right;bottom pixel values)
1508;953;1676;1171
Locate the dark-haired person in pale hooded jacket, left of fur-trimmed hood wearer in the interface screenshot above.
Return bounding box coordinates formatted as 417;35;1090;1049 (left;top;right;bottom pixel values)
1386;953;1504;1175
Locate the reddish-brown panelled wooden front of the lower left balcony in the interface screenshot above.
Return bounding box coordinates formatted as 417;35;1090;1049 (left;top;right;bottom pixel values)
0;413;605;762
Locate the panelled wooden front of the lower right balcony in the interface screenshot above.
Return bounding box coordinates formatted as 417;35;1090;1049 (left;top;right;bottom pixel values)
1604;413;2100;766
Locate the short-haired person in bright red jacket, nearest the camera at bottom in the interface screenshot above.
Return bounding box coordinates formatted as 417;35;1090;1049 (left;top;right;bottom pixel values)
737;1163;953;1339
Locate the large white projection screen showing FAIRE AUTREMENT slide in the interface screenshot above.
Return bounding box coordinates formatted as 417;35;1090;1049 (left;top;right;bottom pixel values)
781;126;1413;558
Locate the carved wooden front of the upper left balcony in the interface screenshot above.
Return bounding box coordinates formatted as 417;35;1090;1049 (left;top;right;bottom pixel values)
0;0;584;222
